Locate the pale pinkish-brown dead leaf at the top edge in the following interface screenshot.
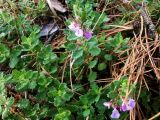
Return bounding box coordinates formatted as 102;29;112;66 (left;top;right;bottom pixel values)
47;0;67;14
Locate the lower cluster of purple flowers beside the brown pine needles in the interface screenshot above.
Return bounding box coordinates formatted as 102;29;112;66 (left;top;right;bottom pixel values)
103;98;136;119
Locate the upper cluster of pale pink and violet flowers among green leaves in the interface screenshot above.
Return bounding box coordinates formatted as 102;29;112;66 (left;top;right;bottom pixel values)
68;22;93;40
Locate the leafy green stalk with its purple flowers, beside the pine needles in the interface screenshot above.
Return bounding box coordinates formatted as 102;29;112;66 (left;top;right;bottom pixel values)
103;77;136;119
